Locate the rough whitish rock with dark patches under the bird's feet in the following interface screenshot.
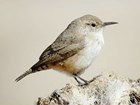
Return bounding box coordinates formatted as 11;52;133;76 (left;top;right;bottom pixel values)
37;73;140;105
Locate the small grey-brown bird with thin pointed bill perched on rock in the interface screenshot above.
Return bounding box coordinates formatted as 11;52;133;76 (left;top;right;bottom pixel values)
16;15;117;84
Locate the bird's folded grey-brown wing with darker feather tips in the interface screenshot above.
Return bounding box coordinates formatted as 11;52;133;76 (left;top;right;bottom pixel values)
33;37;84;68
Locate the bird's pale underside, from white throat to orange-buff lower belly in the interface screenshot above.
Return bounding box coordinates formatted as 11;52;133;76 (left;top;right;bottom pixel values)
52;30;104;74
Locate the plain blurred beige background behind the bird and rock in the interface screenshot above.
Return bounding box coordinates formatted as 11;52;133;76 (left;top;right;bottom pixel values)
0;0;140;105
